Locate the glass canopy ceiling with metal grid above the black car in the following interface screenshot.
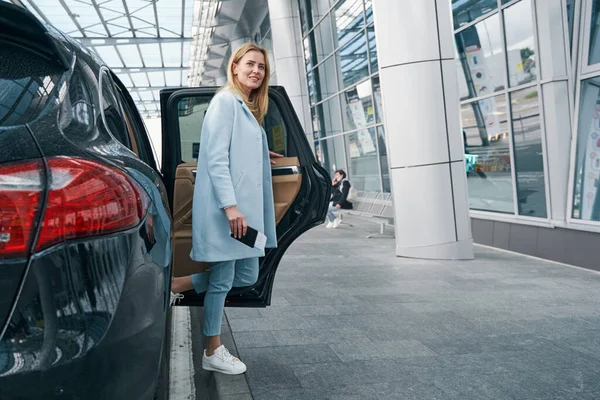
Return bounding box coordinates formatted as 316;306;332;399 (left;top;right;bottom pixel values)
4;0;221;118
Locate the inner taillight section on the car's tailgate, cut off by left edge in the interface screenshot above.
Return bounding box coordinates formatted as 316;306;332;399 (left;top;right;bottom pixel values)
0;161;43;259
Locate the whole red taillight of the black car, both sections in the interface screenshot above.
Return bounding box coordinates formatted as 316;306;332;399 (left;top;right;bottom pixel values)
0;158;150;259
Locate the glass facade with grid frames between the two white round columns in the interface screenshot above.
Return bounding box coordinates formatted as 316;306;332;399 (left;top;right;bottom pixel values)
299;0;390;192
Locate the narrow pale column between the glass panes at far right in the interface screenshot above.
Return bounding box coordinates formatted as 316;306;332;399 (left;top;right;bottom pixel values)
536;0;572;224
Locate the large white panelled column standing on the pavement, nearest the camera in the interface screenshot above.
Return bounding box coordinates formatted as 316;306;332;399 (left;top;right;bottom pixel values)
373;0;473;259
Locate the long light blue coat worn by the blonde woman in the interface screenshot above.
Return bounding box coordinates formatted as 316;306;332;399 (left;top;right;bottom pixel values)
190;91;277;262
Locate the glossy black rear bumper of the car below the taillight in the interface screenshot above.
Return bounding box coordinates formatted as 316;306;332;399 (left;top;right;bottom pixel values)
0;228;169;400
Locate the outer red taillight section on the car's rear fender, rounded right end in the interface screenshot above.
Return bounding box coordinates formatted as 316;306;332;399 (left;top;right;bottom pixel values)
35;158;148;251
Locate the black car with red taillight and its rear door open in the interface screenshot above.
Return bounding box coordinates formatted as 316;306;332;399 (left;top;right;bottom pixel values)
0;2;330;400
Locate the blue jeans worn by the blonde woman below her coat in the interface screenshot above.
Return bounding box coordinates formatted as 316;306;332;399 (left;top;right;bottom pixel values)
192;258;258;336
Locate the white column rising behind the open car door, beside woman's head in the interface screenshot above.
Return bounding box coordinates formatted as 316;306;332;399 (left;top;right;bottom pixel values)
269;0;312;139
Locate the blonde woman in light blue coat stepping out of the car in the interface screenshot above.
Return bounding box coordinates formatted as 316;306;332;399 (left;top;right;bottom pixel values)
172;43;280;375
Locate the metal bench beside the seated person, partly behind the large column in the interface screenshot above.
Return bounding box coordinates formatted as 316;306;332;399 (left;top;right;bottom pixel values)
338;191;394;239
